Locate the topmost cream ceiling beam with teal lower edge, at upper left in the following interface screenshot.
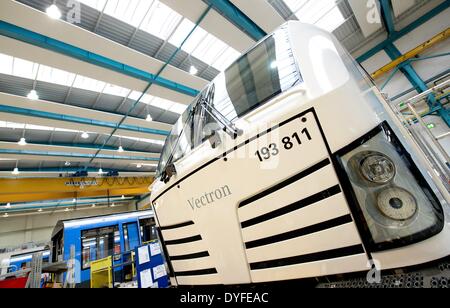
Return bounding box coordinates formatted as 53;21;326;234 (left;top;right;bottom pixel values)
0;0;207;96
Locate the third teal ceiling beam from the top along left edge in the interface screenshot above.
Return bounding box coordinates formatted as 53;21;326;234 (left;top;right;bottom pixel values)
0;149;159;162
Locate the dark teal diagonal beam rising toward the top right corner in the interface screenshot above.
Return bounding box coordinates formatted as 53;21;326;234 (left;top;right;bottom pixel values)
356;0;450;63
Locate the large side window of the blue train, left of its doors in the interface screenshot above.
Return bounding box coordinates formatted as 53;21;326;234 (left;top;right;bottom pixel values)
81;226;120;269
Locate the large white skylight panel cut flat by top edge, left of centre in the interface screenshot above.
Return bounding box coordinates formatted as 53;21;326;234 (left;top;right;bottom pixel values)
104;0;149;27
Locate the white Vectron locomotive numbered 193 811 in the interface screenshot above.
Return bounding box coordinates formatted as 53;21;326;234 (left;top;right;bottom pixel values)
151;22;450;285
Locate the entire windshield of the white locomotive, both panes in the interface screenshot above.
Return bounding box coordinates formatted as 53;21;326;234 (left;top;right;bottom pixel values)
156;27;302;177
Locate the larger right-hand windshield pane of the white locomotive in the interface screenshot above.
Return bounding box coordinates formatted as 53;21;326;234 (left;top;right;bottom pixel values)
220;28;303;121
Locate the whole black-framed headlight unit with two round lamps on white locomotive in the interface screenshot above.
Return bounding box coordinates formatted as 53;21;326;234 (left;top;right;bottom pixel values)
336;123;444;251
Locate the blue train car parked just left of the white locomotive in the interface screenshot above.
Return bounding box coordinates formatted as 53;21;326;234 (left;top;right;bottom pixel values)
52;211;157;287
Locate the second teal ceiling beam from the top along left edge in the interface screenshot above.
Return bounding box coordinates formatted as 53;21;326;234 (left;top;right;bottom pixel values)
0;105;170;136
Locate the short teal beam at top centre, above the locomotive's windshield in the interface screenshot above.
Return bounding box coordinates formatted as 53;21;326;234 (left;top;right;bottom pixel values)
202;0;267;41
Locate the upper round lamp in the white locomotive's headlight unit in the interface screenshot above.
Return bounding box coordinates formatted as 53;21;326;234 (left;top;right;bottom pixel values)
360;152;396;184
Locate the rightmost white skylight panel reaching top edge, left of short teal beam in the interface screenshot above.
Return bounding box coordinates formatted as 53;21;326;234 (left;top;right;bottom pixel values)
141;1;183;40
